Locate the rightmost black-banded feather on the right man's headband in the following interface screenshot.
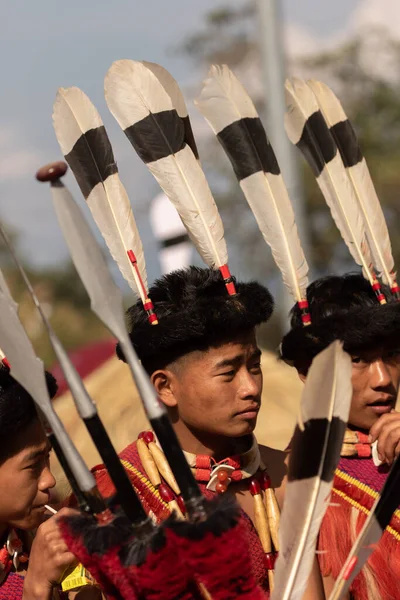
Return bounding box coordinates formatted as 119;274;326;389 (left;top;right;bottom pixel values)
307;80;400;297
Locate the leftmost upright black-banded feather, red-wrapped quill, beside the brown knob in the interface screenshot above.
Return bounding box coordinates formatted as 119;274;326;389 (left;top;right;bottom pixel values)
53;87;157;324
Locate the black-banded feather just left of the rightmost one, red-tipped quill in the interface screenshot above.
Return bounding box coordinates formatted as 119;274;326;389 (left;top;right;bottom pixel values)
285;78;386;304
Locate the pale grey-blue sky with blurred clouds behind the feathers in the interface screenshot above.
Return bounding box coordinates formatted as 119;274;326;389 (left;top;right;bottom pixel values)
0;0;394;282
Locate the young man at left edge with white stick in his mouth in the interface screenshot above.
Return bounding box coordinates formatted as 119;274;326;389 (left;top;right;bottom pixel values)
0;367;99;600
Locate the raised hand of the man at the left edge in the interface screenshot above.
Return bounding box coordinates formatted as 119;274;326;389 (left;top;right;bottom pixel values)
23;508;77;600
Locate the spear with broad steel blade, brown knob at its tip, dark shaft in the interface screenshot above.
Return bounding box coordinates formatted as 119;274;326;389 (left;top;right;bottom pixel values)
38;162;205;516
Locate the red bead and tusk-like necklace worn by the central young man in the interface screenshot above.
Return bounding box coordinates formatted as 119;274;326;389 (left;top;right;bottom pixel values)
137;431;280;591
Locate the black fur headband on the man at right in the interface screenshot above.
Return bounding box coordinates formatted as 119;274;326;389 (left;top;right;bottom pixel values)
281;273;400;362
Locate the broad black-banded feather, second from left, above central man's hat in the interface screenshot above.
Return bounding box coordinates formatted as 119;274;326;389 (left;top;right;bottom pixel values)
104;60;236;294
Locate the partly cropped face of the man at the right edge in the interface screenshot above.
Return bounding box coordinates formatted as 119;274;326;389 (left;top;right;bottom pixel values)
349;348;400;430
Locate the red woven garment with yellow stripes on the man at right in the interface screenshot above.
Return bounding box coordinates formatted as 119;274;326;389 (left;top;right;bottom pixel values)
318;457;400;600
